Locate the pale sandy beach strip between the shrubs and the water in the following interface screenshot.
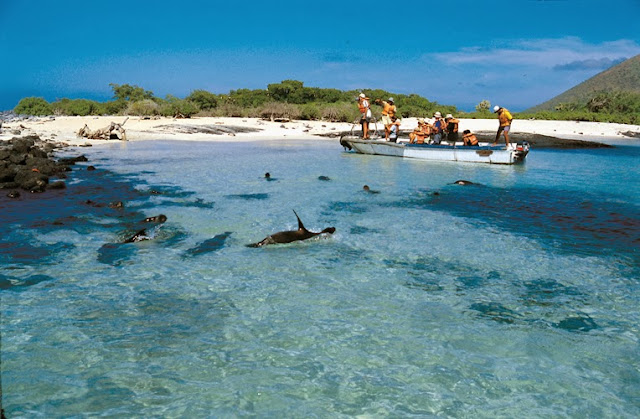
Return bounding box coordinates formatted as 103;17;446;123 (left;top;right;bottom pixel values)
0;116;640;145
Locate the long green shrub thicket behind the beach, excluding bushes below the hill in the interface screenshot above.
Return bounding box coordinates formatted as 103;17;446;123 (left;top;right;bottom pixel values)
14;80;457;122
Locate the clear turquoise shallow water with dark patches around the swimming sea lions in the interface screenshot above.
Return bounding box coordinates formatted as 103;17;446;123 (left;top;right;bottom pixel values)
0;140;640;418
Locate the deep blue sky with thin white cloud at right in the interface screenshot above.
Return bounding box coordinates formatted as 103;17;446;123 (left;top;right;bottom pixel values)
0;0;640;111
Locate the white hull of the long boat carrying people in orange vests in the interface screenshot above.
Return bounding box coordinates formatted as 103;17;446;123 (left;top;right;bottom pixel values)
340;138;529;164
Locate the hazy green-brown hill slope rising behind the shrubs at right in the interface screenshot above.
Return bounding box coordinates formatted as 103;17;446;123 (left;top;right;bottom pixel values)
525;55;640;112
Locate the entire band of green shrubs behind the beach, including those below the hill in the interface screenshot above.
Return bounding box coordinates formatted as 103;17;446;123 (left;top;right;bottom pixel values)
14;80;640;124
